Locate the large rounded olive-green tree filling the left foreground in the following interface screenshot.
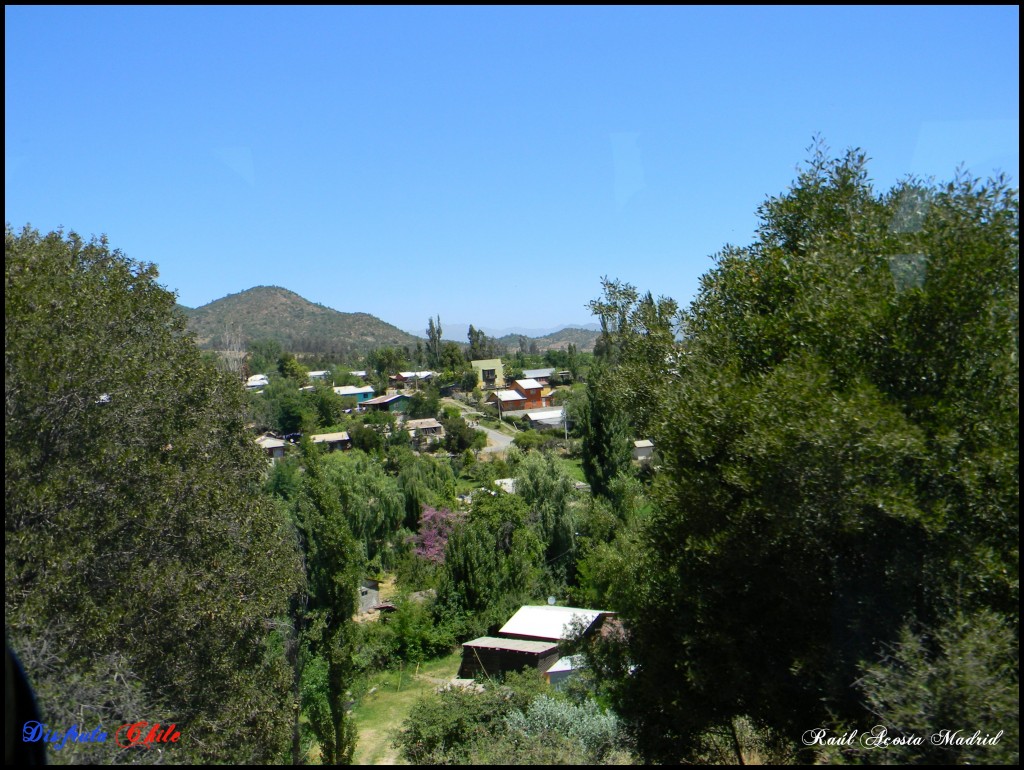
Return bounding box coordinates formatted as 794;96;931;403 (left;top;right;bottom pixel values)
4;226;300;763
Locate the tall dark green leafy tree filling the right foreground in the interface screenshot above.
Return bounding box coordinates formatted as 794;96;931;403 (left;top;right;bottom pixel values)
589;152;1019;762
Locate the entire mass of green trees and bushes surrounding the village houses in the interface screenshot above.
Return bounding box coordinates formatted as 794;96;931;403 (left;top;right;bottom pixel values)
5;147;1019;764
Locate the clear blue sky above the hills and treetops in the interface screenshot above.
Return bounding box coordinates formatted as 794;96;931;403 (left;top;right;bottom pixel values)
4;6;1020;338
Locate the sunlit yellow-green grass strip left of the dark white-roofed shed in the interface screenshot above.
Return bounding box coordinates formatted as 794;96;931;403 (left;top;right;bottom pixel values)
352;651;462;765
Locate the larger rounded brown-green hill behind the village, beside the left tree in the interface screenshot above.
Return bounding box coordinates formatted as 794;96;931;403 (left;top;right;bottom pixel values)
178;286;422;356
